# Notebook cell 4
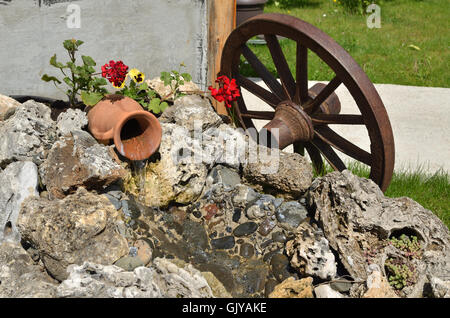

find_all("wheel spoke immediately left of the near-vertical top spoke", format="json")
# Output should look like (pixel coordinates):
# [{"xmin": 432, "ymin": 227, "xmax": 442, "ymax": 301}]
[{"xmin": 264, "ymin": 34, "xmax": 295, "ymax": 100}]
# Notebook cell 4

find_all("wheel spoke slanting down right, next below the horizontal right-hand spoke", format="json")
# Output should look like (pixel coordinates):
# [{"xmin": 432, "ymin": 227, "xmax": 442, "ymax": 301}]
[{"xmin": 315, "ymin": 126, "xmax": 372, "ymax": 166}]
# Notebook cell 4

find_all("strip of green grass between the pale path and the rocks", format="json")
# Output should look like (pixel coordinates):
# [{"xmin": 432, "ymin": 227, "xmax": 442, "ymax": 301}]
[{"xmin": 316, "ymin": 161, "xmax": 450, "ymax": 228}]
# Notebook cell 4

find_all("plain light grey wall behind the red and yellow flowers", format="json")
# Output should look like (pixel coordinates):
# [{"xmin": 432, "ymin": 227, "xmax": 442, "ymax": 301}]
[{"xmin": 0, "ymin": 0, "xmax": 208, "ymax": 97}]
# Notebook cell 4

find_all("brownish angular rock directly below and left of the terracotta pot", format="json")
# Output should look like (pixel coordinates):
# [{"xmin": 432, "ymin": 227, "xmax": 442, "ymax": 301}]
[{"xmin": 39, "ymin": 130, "xmax": 126, "ymax": 198}]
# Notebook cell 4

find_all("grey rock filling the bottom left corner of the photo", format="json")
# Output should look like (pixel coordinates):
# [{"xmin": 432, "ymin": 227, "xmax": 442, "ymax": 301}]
[{"xmin": 0, "ymin": 242, "xmax": 56, "ymax": 298}]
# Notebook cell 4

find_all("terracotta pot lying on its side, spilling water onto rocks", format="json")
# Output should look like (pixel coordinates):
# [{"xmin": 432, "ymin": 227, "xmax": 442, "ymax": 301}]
[{"xmin": 88, "ymin": 95, "xmax": 162, "ymax": 160}]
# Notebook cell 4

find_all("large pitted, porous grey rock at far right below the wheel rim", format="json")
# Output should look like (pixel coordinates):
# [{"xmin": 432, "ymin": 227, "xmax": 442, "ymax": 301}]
[{"xmin": 307, "ymin": 170, "xmax": 450, "ymax": 290}]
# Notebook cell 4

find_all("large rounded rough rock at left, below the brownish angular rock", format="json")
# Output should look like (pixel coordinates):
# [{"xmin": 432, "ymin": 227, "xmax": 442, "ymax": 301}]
[{"xmin": 17, "ymin": 188, "xmax": 128, "ymax": 281}]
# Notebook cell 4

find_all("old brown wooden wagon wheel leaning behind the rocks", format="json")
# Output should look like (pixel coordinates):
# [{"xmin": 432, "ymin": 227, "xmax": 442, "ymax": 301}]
[{"xmin": 220, "ymin": 14, "xmax": 394, "ymax": 191}]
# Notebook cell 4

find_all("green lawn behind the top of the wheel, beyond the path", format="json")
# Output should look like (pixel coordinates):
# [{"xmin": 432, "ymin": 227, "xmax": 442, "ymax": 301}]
[{"xmin": 242, "ymin": 0, "xmax": 450, "ymax": 87}]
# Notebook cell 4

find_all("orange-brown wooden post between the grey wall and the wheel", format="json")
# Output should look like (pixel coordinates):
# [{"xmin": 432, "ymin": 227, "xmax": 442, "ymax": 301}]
[{"xmin": 208, "ymin": 0, "xmax": 236, "ymax": 115}]
